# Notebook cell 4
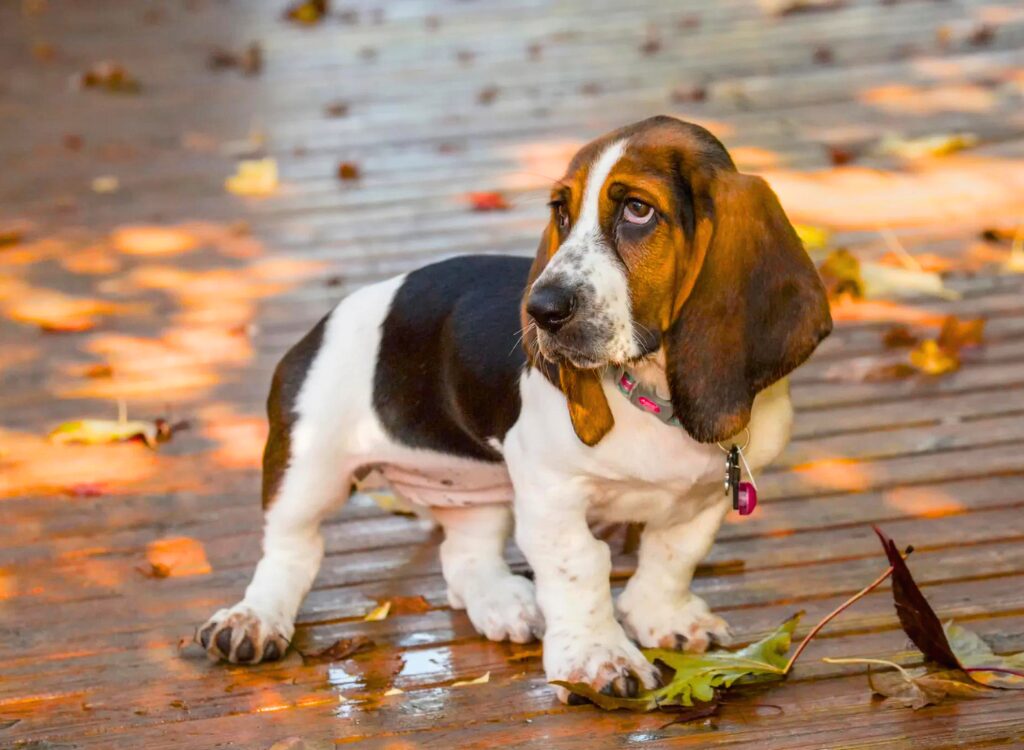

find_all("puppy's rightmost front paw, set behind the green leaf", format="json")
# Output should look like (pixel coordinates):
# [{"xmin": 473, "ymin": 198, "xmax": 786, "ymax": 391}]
[{"xmin": 615, "ymin": 588, "xmax": 732, "ymax": 654}]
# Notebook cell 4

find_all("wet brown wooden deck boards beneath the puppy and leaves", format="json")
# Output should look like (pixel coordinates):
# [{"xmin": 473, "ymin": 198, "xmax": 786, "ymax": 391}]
[{"xmin": 0, "ymin": 0, "xmax": 1024, "ymax": 750}]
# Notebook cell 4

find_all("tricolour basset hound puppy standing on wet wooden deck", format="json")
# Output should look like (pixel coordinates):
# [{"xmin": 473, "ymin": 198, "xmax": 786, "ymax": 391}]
[{"xmin": 196, "ymin": 117, "xmax": 831, "ymax": 701}]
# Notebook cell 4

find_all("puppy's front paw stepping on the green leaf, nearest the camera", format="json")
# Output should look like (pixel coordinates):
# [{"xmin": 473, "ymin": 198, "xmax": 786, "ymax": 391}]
[{"xmin": 544, "ymin": 625, "xmax": 660, "ymax": 703}]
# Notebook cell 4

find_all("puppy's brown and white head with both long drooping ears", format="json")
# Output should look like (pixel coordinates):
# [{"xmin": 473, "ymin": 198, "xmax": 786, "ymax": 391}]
[{"xmin": 522, "ymin": 117, "xmax": 831, "ymax": 446}]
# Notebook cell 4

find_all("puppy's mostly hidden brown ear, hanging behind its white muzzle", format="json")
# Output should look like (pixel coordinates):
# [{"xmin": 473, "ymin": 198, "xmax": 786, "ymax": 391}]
[{"xmin": 519, "ymin": 224, "xmax": 615, "ymax": 446}]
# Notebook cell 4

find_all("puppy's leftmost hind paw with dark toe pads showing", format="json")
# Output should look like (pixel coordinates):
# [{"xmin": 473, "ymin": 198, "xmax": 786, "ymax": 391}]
[{"xmin": 196, "ymin": 603, "xmax": 295, "ymax": 664}]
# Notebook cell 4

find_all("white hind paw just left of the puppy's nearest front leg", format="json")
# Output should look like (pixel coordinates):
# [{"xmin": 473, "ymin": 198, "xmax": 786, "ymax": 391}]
[{"xmin": 460, "ymin": 576, "xmax": 544, "ymax": 643}]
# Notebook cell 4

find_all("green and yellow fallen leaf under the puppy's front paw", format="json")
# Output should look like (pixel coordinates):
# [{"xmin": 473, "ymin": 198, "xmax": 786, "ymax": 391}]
[{"xmin": 552, "ymin": 614, "xmax": 801, "ymax": 711}]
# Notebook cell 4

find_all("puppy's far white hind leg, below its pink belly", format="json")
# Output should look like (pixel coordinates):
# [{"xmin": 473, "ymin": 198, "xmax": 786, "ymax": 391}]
[{"xmin": 431, "ymin": 505, "xmax": 544, "ymax": 643}]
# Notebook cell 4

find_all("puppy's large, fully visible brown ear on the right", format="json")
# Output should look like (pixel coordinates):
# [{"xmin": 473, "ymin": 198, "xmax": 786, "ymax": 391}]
[{"xmin": 665, "ymin": 170, "xmax": 831, "ymax": 443}]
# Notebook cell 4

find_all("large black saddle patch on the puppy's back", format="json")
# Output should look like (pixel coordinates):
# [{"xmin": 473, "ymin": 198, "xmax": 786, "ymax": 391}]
[{"xmin": 374, "ymin": 255, "xmax": 530, "ymax": 461}]
